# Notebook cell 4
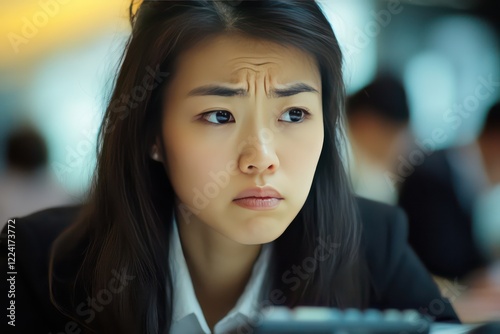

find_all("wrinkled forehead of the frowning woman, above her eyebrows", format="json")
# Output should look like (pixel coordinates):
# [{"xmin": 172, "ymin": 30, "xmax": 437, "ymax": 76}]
[{"xmin": 172, "ymin": 35, "xmax": 321, "ymax": 90}]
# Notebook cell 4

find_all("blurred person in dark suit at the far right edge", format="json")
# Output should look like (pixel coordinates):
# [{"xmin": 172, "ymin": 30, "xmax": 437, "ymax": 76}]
[{"xmin": 399, "ymin": 103, "xmax": 500, "ymax": 279}]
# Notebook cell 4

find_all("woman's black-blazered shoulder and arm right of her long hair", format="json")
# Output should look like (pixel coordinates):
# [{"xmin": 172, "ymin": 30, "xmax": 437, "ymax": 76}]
[{"xmin": 357, "ymin": 198, "xmax": 458, "ymax": 321}]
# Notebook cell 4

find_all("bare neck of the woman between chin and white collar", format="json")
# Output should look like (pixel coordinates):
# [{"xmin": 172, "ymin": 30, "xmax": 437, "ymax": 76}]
[{"xmin": 176, "ymin": 209, "xmax": 261, "ymax": 329}]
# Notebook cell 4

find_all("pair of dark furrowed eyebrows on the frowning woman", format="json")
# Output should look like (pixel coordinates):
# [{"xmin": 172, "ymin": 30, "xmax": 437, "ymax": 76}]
[{"xmin": 188, "ymin": 82, "xmax": 318, "ymax": 97}]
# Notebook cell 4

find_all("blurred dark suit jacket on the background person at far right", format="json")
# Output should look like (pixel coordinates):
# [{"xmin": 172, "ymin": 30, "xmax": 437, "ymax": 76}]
[{"xmin": 399, "ymin": 149, "xmax": 486, "ymax": 279}]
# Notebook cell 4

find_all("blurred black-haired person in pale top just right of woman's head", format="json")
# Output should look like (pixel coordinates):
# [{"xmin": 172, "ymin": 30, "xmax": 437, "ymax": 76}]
[{"xmin": 347, "ymin": 75, "xmax": 410, "ymax": 204}]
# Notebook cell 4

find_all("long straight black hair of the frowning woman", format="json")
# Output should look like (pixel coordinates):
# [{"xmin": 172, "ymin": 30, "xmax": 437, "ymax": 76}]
[{"xmin": 50, "ymin": 0, "xmax": 366, "ymax": 333}]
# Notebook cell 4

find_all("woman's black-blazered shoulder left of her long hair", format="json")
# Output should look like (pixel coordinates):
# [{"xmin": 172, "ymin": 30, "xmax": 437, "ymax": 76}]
[{"xmin": 0, "ymin": 206, "xmax": 80, "ymax": 332}]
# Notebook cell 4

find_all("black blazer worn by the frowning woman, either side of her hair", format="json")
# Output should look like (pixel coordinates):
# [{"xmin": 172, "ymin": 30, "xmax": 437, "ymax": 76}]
[{"xmin": 0, "ymin": 199, "xmax": 458, "ymax": 334}]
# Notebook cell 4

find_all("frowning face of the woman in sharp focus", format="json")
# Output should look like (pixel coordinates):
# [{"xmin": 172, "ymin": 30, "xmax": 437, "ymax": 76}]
[{"xmin": 158, "ymin": 35, "xmax": 323, "ymax": 245}]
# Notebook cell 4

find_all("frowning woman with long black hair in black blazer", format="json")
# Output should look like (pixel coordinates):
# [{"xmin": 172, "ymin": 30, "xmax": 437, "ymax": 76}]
[{"xmin": 1, "ymin": 0, "xmax": 456, "ymax": 333}]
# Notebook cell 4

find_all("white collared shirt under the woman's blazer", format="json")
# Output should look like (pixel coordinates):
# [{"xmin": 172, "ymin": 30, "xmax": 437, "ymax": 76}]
[{"xmin": 169, "ymin": 218, "xmax": 272, "ymax": 334}]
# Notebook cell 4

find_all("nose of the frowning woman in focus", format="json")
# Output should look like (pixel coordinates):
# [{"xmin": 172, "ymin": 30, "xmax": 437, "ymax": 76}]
[{"xmin": 238, "ymin": 133, "xmax": 279, "ymax": 175}]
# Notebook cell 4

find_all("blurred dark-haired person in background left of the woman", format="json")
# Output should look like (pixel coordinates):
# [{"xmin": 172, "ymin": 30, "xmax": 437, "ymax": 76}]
[{"xmin": 0, "ymin": 126, "xmax": 74, "ymax": 228}]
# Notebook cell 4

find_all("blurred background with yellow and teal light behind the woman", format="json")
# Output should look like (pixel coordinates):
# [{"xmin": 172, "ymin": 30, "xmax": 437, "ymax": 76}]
[{"xmin": 0, "ymin": 0, "xmax": 500, "ymax": 321}]
